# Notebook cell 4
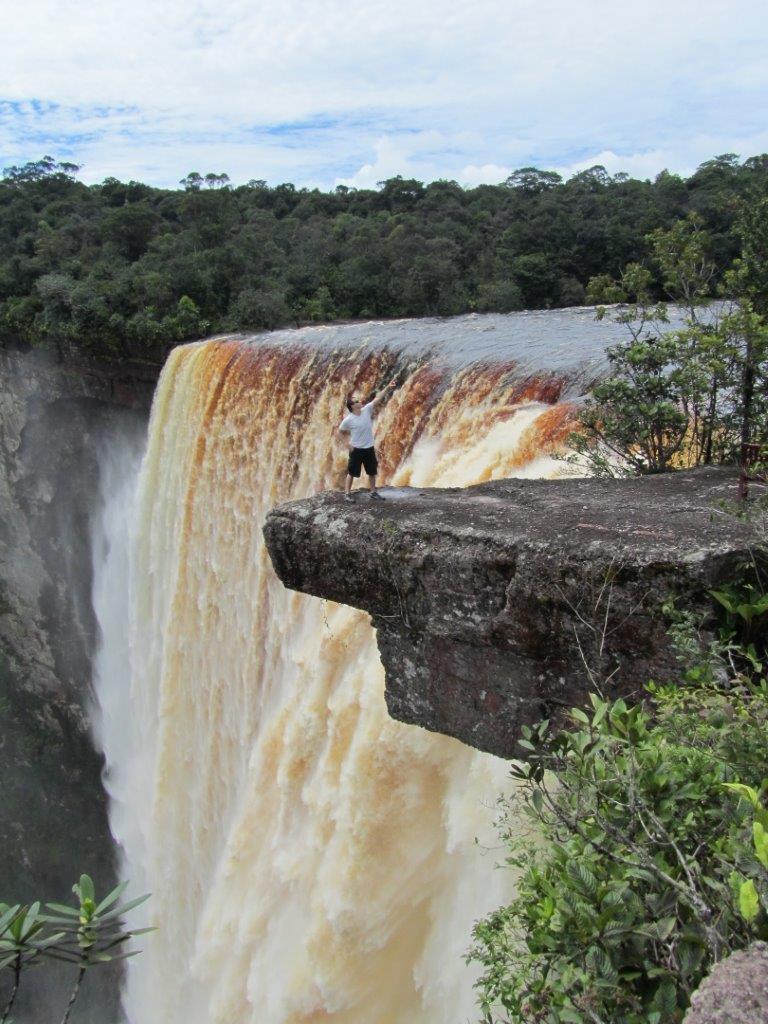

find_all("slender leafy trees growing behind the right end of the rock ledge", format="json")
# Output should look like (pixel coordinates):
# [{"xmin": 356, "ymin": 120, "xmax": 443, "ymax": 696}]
[{"xmin": 569, "ymin": 207, "xmax": 768, "ymax": 476}]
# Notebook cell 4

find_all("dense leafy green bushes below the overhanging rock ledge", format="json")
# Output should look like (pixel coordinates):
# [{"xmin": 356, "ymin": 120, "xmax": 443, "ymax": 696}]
[{"xmin": 470, "ymin": 588, "xmax": 768, "ymax": 1024}]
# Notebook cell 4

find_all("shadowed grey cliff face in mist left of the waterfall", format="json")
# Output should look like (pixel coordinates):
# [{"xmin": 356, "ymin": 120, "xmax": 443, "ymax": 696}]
[{"xmin": 0, "ymin": 350, "xmax": 156, "ymax": 1020}]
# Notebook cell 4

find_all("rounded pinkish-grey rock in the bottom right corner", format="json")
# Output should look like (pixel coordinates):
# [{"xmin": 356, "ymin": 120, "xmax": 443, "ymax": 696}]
[{"xmin": 684, "ymin": 942, "xmax": 768, "ymax": 1024}]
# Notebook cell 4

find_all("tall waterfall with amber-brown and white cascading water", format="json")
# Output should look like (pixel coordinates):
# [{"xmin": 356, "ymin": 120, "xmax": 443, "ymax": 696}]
[{"xmin": 94, "ymin": 340, "xmax": 570, "ymax": 1024}]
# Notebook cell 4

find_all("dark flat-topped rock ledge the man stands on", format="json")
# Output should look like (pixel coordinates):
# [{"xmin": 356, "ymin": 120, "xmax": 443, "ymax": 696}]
[{"xmin": 264, "ymin": 470, "xmax": 758, "ymax": 756}]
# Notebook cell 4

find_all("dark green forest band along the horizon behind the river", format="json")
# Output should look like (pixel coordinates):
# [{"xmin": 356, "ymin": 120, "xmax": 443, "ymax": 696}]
[{"xmin": 0, "ymin": 154, "xmax": 768, "ymax": 361}]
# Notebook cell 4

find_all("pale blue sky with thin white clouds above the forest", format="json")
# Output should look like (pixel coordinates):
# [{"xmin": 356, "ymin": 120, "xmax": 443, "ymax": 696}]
[{"xmin": 0, "ymin": 0, "xmax": 768, "ymax": 187}]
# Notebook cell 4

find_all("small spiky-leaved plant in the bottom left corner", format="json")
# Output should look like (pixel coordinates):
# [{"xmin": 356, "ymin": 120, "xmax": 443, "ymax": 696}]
[{"xmin": 0, "ymin": 874, "xmax": 152, "ymax": 1024}]
